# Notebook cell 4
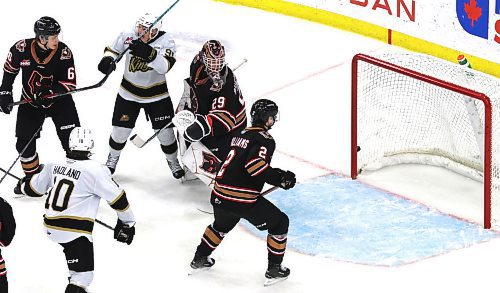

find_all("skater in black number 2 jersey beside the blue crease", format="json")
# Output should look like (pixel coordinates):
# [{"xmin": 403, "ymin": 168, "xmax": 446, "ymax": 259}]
[{"xmin": 191, "ymin": 99, "xmax": 295, "ymax": 285}]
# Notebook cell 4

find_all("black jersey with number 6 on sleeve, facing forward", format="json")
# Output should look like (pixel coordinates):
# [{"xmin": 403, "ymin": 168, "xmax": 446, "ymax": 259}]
[{"xmin": 2, "ymin": 38, "xmax": 76, "ymax": 100}]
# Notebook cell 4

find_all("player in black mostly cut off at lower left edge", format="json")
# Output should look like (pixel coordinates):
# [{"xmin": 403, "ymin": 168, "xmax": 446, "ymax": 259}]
[{"xmin": 0, "ymin": 197, "xmax": 16, "ymax": 292}]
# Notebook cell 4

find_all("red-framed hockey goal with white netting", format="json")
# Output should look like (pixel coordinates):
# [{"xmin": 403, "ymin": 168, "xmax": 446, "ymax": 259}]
[{"xmin": 351, "ymin": 53, "xmax": 500, "ymax": 228}]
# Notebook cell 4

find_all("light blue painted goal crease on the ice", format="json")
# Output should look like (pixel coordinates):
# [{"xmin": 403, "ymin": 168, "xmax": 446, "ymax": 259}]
[{"xmin": 242, "ymin": 175, "xmax": 500, "ymax": 266}]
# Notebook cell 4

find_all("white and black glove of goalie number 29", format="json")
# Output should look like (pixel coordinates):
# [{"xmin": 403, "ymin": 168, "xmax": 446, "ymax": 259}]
[{"xmin": 172, "ymin": 110, "xmax": 212, "ymax": 142}]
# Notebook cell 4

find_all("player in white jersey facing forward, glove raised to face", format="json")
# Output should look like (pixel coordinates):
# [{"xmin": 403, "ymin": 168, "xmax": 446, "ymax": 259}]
[{"xmin": 98, "ymin": 13, "xmax": 184, "ymax": 179}]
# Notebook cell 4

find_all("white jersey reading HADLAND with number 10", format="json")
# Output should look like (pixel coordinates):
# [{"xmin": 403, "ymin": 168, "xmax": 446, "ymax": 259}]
[{"xmin": 22, "ymin": 159, "xmax": 135, "ymax": 243}]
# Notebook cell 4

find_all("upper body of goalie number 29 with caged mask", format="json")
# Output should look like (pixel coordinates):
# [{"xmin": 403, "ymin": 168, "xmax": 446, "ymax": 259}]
[{"xmin": 177, "ymin": 40, "xmax": 247, "ymax": 160}]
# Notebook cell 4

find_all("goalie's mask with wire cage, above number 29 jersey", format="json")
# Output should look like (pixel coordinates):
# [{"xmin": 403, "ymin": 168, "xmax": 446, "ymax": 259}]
[{"xmin": 200, "ymin": 40, "xmax": 227, "ymax": 91}]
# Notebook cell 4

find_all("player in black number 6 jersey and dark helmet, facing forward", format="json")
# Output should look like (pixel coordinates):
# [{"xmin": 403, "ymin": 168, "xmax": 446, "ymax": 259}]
[{"xmin": 0, "ymin": 16, "xmax": 80, "ymax": 194}]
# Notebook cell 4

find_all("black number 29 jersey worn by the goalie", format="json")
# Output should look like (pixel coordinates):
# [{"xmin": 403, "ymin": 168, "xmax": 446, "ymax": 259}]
[{"xmin": 188, "ymin": 54, "xmax": 247, "ymax": 159}]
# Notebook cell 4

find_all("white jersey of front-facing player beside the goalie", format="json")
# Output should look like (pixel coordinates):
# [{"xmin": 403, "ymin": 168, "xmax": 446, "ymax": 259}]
[{"xmin": 104, "ymin": 31, "xmax": 176, "ymax": 103}]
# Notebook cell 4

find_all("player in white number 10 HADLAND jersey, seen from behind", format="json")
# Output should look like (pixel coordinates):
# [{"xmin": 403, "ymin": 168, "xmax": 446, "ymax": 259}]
[{"xmin": 21, "ymin": 127, "xmax": 135, "ymax": 293}]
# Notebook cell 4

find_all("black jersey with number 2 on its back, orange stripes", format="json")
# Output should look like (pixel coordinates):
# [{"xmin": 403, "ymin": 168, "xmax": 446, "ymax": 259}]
[{"xmin": 212, "ymin": 127, "xmax": 283, "ymax": 204}]
